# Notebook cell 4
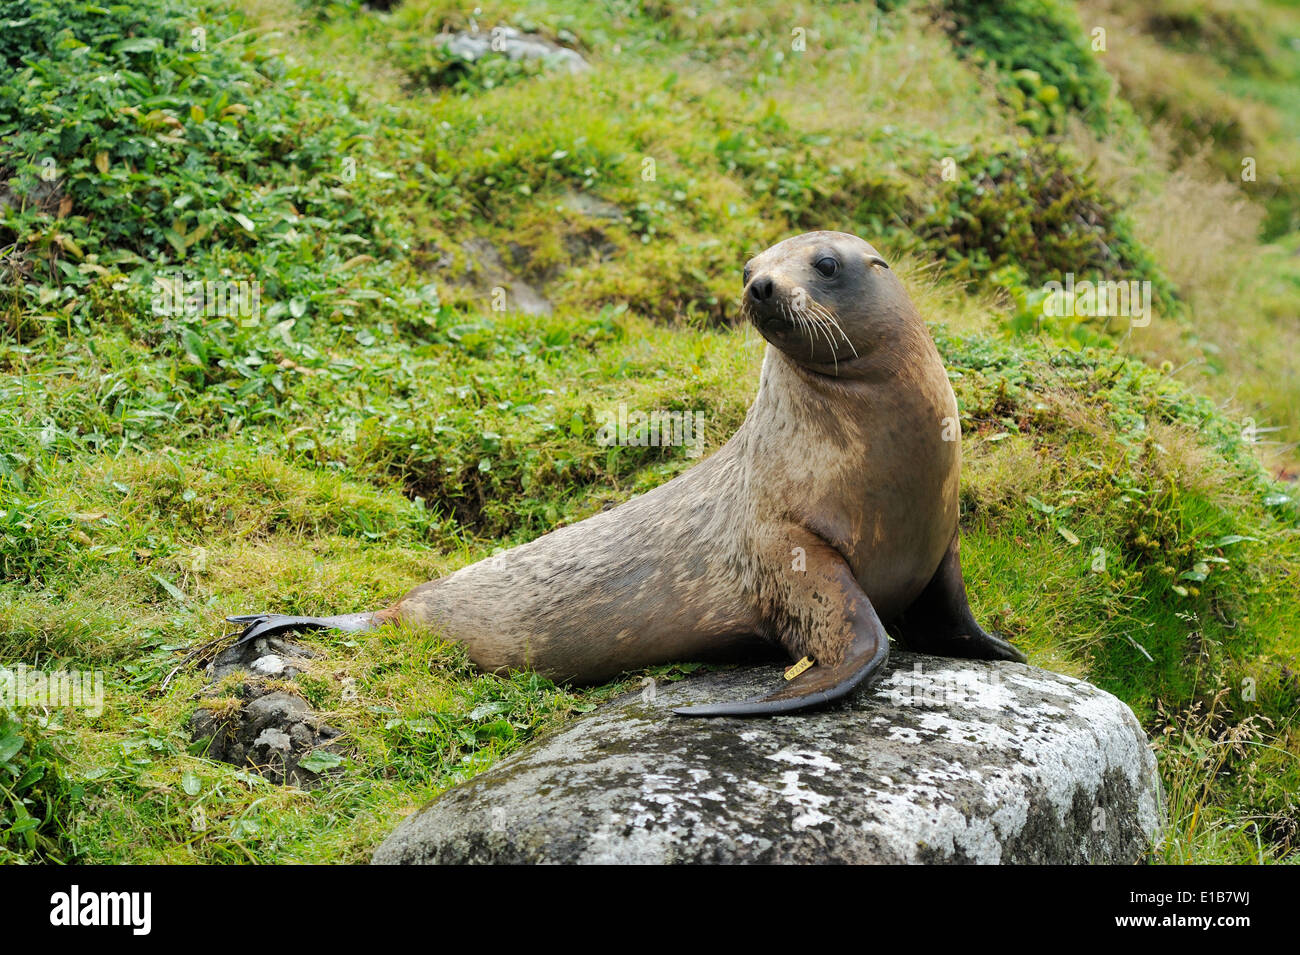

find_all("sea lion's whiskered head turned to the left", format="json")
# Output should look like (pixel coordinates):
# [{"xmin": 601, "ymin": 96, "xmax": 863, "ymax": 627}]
[{"xmin": 741, "ymin": 233, "xmax": 919, "ymax": 377}]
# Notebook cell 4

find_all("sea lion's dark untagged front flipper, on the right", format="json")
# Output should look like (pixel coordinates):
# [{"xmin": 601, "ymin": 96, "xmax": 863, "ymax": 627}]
[{"xmin": 897, "ymin": 531, "xmax": 1027, "ymax": 663}]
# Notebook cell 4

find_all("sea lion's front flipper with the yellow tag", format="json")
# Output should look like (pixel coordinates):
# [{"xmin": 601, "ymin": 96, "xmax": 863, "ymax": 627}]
[{"xmin": 672, "ymin": 542, "xmax": 889, "ymax": 716}]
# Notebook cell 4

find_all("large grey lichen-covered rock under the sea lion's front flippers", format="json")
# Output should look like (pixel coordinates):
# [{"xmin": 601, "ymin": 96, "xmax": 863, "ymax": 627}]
[{"xmin": 374, "ymin": 652, "xmax": 1162, "ymax": 863}]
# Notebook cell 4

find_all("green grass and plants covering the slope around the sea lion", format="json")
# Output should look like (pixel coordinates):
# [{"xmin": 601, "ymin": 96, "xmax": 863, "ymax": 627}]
[{"xmin": 0, "ymin": 0, "xmax": 1300, "ymax": 863}]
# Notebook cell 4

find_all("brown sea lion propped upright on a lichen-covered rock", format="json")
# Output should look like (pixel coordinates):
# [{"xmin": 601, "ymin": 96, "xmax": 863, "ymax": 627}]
[{"xmin": 231, "ymin": 231, "xmax": 1024, "ymax": 716}]
